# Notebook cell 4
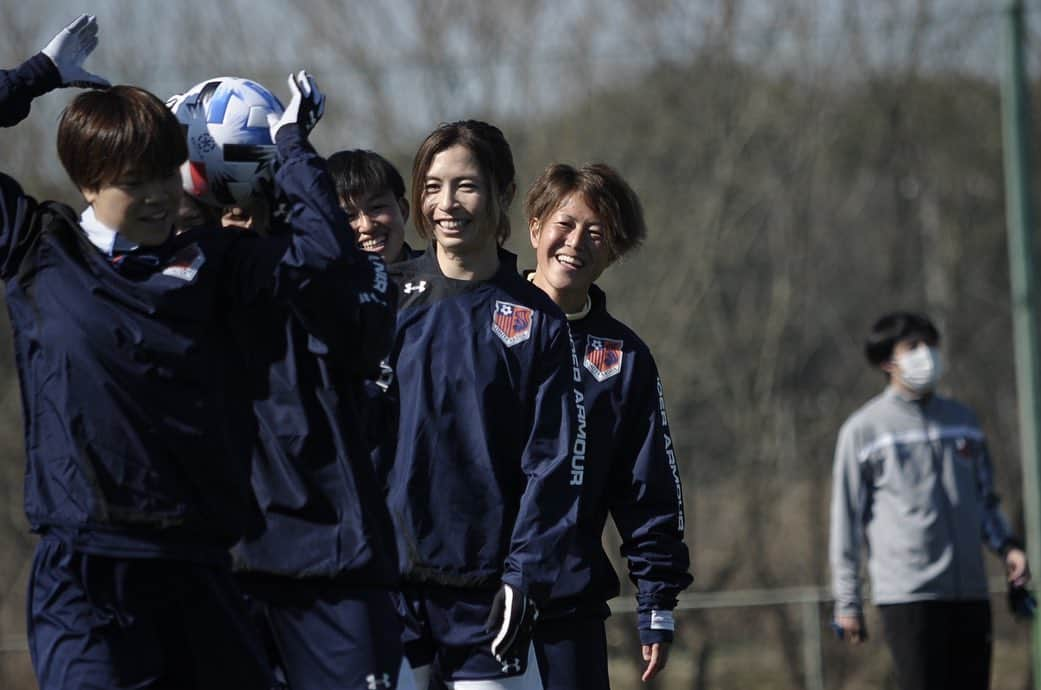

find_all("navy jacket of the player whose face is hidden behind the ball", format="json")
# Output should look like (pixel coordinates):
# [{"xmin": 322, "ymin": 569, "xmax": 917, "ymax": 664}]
[{"xmin": 232, "ymin": 250, "xmax": 398, "ymax": 586}]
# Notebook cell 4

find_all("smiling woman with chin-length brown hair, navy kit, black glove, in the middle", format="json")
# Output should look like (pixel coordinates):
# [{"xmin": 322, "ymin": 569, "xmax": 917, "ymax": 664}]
[{"xmin": 380, "ymin": 121, "xmax": 585, "ymax": 690}]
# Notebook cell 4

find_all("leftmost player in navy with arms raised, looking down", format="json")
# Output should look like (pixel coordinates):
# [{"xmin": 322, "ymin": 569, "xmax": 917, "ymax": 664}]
[{"xmin": 0, "ymin": 15, "xmax": 355, "ymax": 690}]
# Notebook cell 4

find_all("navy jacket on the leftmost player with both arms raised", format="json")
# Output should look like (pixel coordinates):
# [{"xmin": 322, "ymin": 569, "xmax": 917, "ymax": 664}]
[{"xmin": 0, "ymin": 54, "xmax": 366, "ymax": 561}]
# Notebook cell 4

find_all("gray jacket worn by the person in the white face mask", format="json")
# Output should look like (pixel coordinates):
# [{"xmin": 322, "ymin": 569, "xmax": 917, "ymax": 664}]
[{"xmin": 829, "ymin": 387, "xmax": 1015, "ymax": 616}]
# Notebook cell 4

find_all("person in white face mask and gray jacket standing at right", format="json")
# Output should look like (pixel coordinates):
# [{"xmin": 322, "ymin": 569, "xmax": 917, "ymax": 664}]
[{"xmin": 830, "ymin": 311, "xmax": 1031, "ymax": 690}]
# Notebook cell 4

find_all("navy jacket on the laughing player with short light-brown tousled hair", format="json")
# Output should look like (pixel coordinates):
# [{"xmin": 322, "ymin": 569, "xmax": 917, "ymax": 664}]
[{"xmin": 541, "ymin": 285, "xmax": 691, "ymax": 644}]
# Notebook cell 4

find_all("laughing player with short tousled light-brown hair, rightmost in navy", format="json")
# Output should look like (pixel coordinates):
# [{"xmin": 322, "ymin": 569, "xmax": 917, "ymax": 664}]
[{"xmin": 525, "ymin": 163, "xmax": 691, "ymax": 690}]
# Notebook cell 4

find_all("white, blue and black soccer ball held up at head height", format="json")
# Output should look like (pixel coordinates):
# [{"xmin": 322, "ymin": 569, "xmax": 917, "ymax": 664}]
[{"xmin": 167, "ymin": 77, "xmax": 284, "ymax": 207}]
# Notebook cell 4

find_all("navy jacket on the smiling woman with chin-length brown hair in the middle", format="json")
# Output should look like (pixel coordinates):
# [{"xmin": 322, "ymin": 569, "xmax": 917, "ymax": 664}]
[{"xmin": 384, "ymin": 248, "xmax": 585, "ymax": 603}]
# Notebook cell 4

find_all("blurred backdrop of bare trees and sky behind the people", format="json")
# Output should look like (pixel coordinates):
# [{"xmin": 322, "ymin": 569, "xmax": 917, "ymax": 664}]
[{"xmin": 0, "ymin": 0, "xmax": 1038, "ymax": 689}]
